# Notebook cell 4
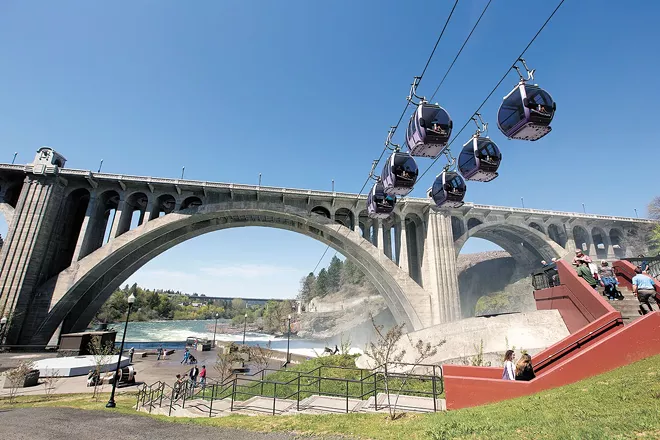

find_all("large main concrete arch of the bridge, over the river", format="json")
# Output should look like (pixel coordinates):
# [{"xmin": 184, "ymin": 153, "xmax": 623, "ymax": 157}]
[{"xmin": 32, "ymin": 201, "xmax": 432, "ymax": 344}]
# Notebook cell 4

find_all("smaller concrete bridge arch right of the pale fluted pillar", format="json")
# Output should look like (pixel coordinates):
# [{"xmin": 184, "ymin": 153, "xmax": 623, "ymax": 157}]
[{"xmin": 454, "ymin": 222, "xmax": 566, "ymax": 267}]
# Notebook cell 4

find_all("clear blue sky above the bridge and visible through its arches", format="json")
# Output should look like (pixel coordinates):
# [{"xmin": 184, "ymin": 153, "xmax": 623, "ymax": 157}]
[{"xmin": 0, "ymin": 0, "xmax": 660, "ymax": 297}]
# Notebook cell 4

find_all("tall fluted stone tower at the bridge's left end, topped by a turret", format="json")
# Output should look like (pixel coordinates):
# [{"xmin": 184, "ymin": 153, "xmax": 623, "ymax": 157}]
[{"xmin": 0, "ymin": 147, "xmax": 66, "ymax": 344}]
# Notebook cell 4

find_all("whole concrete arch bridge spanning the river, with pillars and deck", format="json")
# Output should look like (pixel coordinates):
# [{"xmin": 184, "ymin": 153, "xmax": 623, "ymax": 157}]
[{"xmin": 0, "ymin": 147, "xmax": 655, "ymax": 344}]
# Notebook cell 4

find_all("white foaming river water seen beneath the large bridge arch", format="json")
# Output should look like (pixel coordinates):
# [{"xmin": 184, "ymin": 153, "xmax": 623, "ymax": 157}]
[{"xmin": 108, "ymin": 319, "xmax": 338, "ymax": 357}]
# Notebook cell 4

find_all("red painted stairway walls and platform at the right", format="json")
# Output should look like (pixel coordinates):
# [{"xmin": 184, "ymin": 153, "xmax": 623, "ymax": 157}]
[{"xmin": 443, "ymin": 261, "xmax": 660, "ymax": 410}]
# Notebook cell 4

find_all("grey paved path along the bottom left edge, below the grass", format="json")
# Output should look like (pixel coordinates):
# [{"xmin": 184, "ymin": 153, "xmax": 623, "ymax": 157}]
[{"xmin": 0, "ymin": 408, "xmax": 346, "ymax": 440}]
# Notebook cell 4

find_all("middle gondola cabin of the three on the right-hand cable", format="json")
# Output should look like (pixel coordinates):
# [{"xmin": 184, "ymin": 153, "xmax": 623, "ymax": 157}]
[{"xmin": 458, "ymin": 135, "xmax": 502, "ymax": 182}]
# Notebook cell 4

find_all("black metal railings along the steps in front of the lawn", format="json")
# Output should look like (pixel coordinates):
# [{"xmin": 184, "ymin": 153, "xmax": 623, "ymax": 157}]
[{"xmin": 136, "ymin": 362, "xmax": 444, "ymax": 417}]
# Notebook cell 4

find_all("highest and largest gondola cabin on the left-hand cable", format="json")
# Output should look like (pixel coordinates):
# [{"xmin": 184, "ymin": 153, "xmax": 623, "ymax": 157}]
[{"xmin": 406, "ymin": 102, "xmax": 453, "ymax": 158}]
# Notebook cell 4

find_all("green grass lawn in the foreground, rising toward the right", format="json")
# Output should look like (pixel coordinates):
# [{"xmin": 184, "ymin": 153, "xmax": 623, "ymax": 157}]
[{"xmin": 0, "ymin": 356, "xmax": 660, "ymax": 440}]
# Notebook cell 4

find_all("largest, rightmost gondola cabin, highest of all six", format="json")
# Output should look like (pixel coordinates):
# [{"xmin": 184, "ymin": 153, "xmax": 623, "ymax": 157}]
[{"xmin": 497, "ymin": 82, "xmax": 557, "ymax": 141}]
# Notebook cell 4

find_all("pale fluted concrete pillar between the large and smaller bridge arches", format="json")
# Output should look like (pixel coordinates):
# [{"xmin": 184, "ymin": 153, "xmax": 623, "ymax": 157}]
[{"xmin": 422, "ymin": 211, "xmax": 461, "ymax": 324}]
